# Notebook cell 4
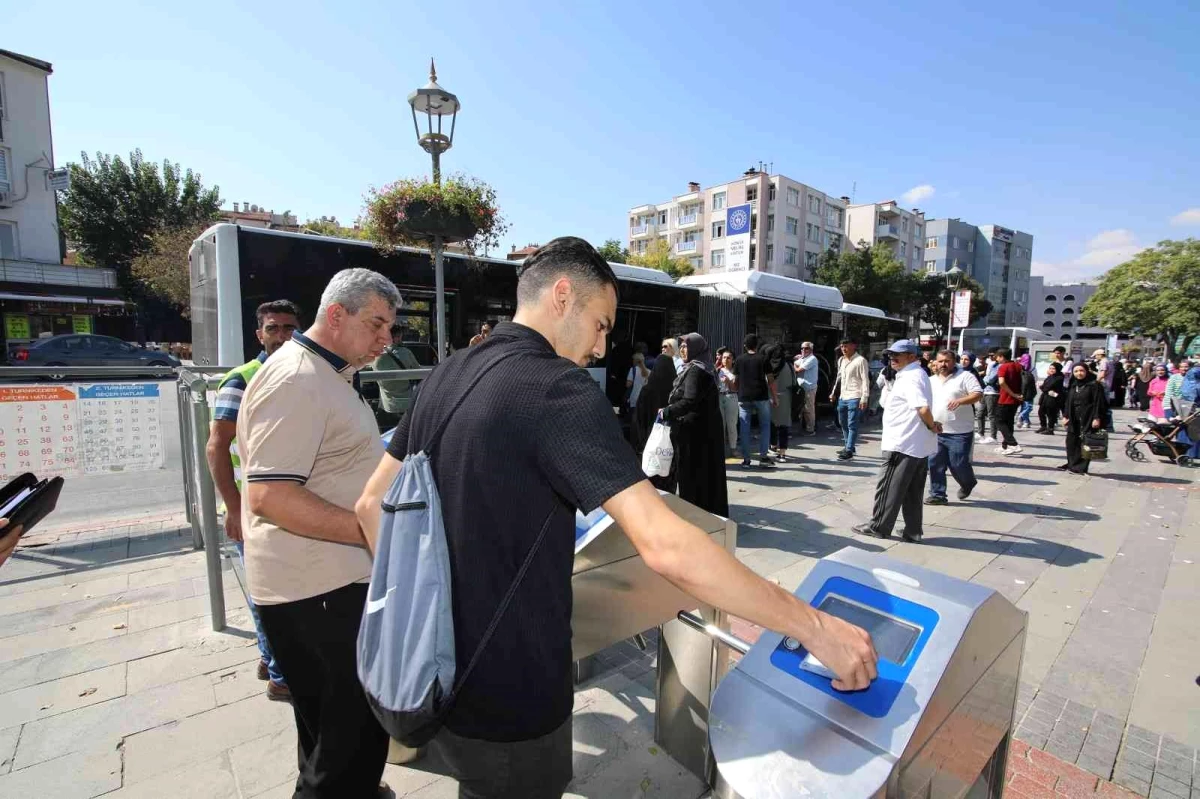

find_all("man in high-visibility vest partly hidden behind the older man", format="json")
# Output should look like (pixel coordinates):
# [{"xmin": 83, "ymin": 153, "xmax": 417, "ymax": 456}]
[{"xmin": 206, "ymin": 300, "xmax": 300, "ymax": 702}]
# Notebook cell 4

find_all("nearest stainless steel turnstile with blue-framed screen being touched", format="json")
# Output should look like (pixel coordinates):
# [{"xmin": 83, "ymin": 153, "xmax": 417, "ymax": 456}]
[{"xmin": 705, "ymin": 547, "xmax": 1026, "ymax": 799}]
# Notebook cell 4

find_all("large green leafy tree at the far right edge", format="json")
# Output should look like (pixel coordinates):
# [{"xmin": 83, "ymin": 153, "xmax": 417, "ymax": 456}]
[{"xmin": 1080, "ymin": 238, "xmax": 1200, "ymax": 359}]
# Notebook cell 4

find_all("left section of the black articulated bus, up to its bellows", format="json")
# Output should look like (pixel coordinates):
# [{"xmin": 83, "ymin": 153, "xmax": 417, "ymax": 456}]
[{"xmin": 188, "ymin": 223, "xmax": 700, "ymax": 392}]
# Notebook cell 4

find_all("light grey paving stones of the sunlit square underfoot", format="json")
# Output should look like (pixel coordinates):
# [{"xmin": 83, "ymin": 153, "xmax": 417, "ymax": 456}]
[{"xmin": 0, "ymin": 410, "xmax": 1200, "ymax": 799}]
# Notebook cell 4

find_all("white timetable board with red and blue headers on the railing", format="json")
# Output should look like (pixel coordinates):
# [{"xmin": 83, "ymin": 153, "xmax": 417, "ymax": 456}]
[{"xmin": 0, "ymin": 383, "xmax": 166, "ymax": 480}]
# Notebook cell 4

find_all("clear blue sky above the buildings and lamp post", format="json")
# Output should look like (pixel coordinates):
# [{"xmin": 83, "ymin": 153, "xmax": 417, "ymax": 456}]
[{"xmin": 9, "ymin": 0, "xmax": 1200, "ymax": 280}]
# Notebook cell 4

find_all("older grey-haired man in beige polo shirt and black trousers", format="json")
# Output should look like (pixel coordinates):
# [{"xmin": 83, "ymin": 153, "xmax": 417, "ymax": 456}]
[{"xmin": 238, "ymin": 269, "xmax": 400, "ymax": 799}]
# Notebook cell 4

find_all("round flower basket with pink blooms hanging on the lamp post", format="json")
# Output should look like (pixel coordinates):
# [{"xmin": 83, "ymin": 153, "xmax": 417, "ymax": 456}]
[{"xmin": 365, "ymin": 175, "xmax": 508, "ymax": 253}]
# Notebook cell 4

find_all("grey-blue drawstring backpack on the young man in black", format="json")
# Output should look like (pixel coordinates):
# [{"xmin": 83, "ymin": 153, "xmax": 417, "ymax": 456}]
[{"xmin": 358, "ymin": 353, "xmax": 551, "ymax": 749}]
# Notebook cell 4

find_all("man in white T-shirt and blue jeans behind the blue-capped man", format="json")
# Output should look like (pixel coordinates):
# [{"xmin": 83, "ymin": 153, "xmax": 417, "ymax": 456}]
[{"xmin": 925, "ymin": 349, "xmax": 983, "ymax": 505}]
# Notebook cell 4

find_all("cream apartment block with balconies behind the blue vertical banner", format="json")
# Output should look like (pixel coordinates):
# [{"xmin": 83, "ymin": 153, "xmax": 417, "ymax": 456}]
[{"xmin": 629, "ymin": 169, "xmax": 846, "ymax": 280}]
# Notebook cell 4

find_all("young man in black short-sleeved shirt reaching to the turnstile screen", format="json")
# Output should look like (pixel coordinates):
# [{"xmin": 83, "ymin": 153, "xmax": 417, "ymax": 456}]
[{"xmin": 356, "ymin": 238, "xmax": 876, "ymax": 799}]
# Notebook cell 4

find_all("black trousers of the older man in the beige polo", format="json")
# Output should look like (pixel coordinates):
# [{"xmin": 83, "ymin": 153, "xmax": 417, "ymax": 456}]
[{"xmin": 258, "ymin": 583, "xmax": 388, "ymax": 799}]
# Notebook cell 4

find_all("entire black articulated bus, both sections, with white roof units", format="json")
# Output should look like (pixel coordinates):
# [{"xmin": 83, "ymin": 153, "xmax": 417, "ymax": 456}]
[{"xmin": 188, "ymin": 223, "xmax": 902, "ymax": 405}]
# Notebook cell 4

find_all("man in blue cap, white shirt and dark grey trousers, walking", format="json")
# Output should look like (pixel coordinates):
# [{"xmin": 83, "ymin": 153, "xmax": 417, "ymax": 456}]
[{"xmin": 853, "ymin": 338, "xmax": 942, "ymax": 543}]
